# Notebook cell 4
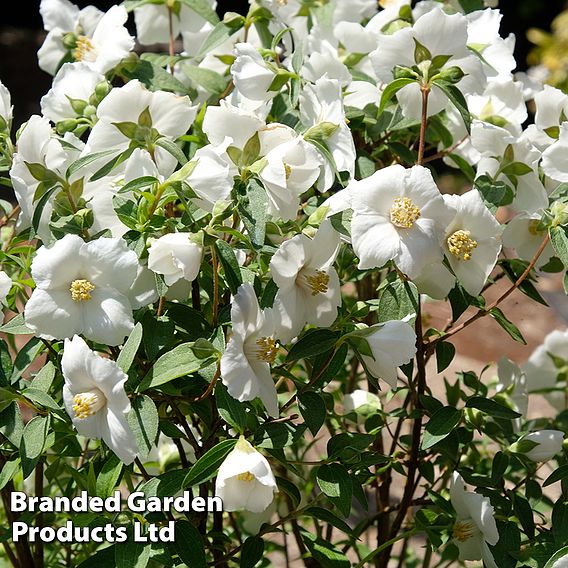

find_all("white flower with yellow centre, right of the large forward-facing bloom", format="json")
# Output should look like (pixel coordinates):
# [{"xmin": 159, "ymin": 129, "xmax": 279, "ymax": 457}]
[{"xmin": 444, "ymin": 191, "xmax": 501, "ymax": 296}]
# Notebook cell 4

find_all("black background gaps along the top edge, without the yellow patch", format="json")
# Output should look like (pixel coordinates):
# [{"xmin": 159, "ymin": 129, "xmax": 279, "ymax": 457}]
[{"xmin": 0, "ymin": 0, "xmax": 567, "ymax": 127}]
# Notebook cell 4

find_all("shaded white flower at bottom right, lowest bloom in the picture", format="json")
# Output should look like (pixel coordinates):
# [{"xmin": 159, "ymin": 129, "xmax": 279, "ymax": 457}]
[{"xmin": 450, "ymin": 472, "xmax": 499, "ymax": 568}]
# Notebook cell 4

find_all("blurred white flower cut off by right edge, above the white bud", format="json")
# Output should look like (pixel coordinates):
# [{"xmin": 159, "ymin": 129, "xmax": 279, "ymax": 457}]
[{"xmin": 522, "ymin": 329, "xmax": 568, "ymax": 412}]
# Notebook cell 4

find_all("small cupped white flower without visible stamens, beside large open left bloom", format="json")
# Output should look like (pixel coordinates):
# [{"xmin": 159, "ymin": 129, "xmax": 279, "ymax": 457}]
[{"xmin": 148, "ymin": 233, "xmax": 203, "ymax": 286}]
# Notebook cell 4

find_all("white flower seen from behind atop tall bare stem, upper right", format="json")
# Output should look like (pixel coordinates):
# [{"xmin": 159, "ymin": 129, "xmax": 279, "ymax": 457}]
[{"xmin": 369, "ymin": 8, "xmax": 487, "ymax": 119}]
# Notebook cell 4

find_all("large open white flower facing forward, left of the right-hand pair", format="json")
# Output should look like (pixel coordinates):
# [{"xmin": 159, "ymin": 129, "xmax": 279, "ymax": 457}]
[{"xmin": 347, "ymin": 164, "xmax": 450, "ymax": 278}]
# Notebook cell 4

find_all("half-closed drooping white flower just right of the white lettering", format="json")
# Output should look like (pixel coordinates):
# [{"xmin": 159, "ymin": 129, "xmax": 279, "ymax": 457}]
[{"xmin": 215, "ymin": 436, "xmax": 278, "ymax": 513}]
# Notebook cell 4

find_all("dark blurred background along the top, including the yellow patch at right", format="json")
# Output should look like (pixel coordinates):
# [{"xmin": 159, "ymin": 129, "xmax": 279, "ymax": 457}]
[{"xmin": 0, "ymin": 0, "xmax": 568, "ymax": 128}]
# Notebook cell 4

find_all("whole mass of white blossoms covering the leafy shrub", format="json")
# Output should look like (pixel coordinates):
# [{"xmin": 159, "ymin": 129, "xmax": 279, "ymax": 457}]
[{"xmin": 0, "ymin": 0, "xmax": 568, "ymax": 568}]
